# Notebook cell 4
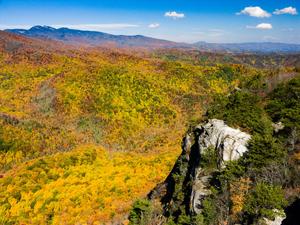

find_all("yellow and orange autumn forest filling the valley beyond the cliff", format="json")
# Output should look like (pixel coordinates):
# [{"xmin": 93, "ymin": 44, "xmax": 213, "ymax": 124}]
[{"xmin": 0, "ymin": 32, "xmax": 297, "ymax": 225}]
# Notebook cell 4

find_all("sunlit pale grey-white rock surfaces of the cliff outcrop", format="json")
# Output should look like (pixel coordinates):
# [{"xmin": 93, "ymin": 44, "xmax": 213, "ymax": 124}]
[{"xmin": 190, "ymin": 119, "xmax": 251, "ymax": 214}]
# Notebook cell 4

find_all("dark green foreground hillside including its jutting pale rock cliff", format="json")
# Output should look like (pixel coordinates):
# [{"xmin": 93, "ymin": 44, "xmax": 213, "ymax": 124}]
[{"xmin": 129, "ymin": 75, "xmax": 300, "ymax": 225}]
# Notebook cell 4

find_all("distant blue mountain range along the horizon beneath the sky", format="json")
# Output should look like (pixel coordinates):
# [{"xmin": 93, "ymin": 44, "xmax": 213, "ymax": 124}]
[{"xmin": 5, "ymin": 26, "xmax": 300, "ymax": 53}]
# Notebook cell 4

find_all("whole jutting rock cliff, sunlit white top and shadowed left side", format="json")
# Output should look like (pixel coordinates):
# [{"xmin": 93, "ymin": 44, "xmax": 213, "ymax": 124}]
[{"xmin": 149, "ymin": 119, "xmax": 251, "ymax": 218}]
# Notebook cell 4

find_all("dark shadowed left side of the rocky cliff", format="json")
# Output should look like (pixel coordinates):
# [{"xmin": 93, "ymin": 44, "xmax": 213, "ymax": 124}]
[{"xmin": 148, "ymin": 129, "xmax": 203, "ymax": 218}]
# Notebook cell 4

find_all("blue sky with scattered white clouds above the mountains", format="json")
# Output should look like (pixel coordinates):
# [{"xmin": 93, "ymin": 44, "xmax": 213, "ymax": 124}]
[{"xmin": 0, "ymin": 0, "xmax": 300, "ymax": 44}]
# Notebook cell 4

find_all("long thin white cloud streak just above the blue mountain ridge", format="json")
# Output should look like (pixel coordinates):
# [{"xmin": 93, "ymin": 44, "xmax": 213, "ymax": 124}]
[{"xmin": 51, "ymin": 23, "xmax": 139, "ymax": 31}]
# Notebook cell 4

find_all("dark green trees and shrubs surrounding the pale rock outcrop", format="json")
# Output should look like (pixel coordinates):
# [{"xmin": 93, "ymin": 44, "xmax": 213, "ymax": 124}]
[{"xmin": 130, "ymin": 71, "xmax": 300, "ymax": 225}]
